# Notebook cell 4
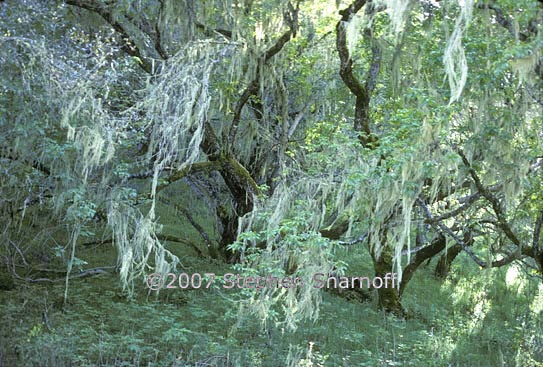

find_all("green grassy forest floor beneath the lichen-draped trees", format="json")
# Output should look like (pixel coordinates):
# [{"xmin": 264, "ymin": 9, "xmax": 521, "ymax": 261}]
[{"xmin": 0, "ymin": 245, "xmax": 543, "ymax": 367}]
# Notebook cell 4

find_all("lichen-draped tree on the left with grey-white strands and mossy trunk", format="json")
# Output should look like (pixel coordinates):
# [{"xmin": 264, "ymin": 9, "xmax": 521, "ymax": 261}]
[{"xmin": 4, "ymin": 1, "xmax": 306, "ymax": 294}]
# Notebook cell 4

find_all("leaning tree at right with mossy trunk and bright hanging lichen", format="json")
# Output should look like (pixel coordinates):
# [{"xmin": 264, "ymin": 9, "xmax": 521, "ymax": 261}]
[{"xmin": 328, "ymin": 1, "xmax": 542, "ymax": 314}]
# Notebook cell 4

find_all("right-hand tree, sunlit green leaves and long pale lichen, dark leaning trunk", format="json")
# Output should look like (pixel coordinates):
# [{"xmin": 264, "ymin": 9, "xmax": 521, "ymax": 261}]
[{"xmin": 235, "ymin": 1, "xmax": 542, "ymax": 322}]
